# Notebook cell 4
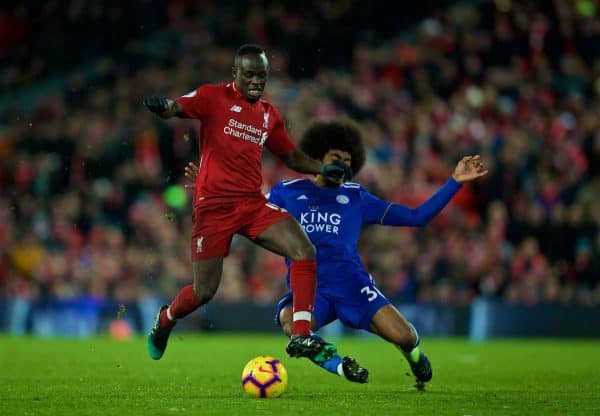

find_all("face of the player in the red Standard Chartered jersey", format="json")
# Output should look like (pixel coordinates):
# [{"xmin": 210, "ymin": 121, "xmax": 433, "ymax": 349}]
[{"xmin": 233, "ymin": 53, "xmax": 269, "ymax": 102}]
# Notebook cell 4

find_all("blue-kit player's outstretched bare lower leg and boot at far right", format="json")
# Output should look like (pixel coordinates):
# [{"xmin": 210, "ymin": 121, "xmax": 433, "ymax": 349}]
[{"xmin": 371, "ymin": 305, "xmax": 432, "ymax": 389}]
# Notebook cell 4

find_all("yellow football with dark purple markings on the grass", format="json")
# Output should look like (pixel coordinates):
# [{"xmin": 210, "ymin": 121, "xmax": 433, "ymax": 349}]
[{"xmin": 242, "ymin": 356, "xmax": 287, "ymax": 398}]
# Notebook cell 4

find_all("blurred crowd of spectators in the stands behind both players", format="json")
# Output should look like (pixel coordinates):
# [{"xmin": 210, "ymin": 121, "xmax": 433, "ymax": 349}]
[{"xmin": 0, "ymin": 0, "xmax": 600, "ymax": 305}]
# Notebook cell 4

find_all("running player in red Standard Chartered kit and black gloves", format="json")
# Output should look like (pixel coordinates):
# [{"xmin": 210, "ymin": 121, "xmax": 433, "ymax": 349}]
[{"xmin": 144, "ymin": 45, "xmax": 336, "ymax": 362}]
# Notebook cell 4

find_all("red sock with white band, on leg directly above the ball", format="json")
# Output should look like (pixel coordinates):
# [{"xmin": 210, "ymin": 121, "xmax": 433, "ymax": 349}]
[{"xmin": 290, "ymin": 260, "xmax": 317, "ymax": 335}]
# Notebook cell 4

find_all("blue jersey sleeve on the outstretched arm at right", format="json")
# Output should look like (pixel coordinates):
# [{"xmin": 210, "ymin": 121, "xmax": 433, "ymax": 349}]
[{"xmin": 361, "ymin": 178, "xmax": 462, "ymax": 227}]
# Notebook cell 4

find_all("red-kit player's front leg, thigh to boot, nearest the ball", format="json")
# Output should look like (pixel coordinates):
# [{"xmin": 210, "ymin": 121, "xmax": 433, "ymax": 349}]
[{"xmin": 255, "ymin": 217, "xmax": 336, "ymax": 362}]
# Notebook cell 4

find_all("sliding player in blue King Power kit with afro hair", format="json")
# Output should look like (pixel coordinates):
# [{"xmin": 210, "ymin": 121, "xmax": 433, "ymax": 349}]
[{"xmin": 186, "ymin": 120, "xmax": 487, "ymax": 386}]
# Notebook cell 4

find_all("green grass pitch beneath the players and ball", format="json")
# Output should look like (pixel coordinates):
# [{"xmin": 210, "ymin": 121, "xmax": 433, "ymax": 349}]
[{"xmin": 0, "ymin": 332, "xmax": 600, "ymax": 416}]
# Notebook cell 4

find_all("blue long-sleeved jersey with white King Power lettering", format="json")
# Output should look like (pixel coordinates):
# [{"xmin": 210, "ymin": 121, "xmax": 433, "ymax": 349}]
[{"xmin": 268, "ymin": 179, "xmax": 460, "ymax": 290}]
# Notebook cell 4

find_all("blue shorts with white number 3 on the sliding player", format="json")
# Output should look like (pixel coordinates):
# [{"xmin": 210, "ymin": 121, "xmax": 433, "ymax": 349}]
[{"xmin": 275, "ymin": 277, "xmax": 390, "ymax": 331}]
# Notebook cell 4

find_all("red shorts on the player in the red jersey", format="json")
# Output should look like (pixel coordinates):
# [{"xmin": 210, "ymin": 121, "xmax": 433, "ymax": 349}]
[{"xmin": 191, "ymin": 194, "xmax": 290, "ymax": 261}]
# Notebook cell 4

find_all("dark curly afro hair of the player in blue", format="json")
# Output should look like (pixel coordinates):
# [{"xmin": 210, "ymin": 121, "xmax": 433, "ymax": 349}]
[{"xmin": 300, "ymin": 119, "xmax": 366, "ymax": 179}]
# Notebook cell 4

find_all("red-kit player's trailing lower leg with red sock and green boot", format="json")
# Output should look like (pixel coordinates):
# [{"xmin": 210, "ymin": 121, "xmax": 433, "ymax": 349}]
[{"xmin": 147, "ymin": 257, "xmax": 223, "ymax": 360}]
